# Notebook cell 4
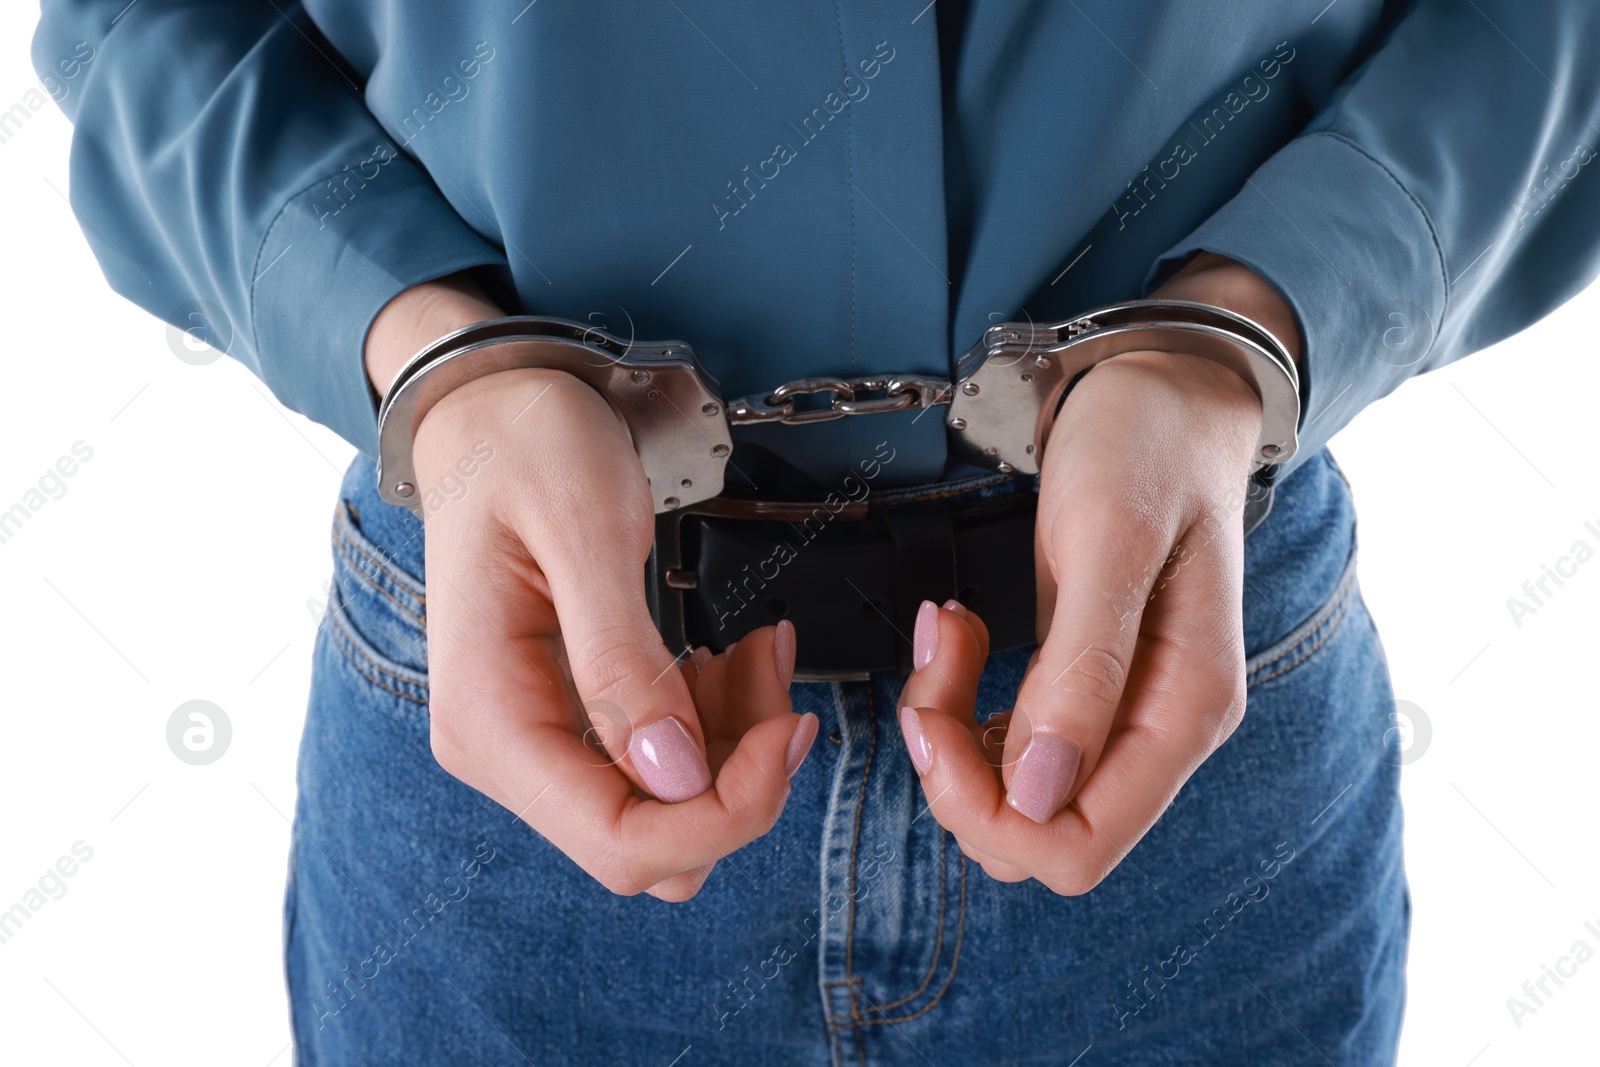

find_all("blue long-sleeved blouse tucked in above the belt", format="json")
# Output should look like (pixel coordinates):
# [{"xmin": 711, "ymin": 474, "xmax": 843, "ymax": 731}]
[{"xmin": 32, "ymin": 0, "xmax": 1600, "ymax": 483}]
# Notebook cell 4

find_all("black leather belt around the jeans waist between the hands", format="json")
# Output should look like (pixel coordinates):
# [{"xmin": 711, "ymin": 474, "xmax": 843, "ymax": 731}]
[{"xmin": 646, "ymin": 485, "xmax": 1038, "ymax": 681}]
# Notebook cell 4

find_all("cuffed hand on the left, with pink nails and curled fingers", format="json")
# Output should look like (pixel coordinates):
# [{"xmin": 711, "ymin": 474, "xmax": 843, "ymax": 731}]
[{"xmin": 370, "ymin": 278, "xmax": 818, "ymax": 901}]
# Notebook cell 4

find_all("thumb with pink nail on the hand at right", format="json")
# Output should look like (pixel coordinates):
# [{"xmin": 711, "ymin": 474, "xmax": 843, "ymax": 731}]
[{"xmin": 1002, "ymin": 483, "xmax": 1176, "ymax": 822}]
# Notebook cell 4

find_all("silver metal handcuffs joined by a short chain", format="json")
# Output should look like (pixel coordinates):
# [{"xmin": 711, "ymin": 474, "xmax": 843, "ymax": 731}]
[{"xmin": 378, "ymin": 301, "xmax": 1301, "ymax": 525}]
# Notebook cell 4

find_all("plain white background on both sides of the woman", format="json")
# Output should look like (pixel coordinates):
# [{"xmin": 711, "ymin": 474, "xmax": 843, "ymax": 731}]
[{"xmin": 0, "ymin": 5, "xmax": 1600, "ymax": 1067}]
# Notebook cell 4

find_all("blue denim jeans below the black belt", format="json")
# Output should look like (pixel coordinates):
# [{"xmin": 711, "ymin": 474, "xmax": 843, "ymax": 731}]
[{"xmin": 285, "ymin": 451, "xmax": 1410, "ymax": 1067}]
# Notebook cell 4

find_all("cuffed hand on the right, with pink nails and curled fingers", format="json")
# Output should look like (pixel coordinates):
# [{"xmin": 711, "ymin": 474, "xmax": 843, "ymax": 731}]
[{"xmin": 901, "ymin": 352, "xmax": 1261, "ymax": 894}]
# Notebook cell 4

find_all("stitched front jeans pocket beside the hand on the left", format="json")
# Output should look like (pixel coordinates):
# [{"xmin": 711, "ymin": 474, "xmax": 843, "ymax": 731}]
[{"xmin": 328, "ymin": 498, "xmax": 427, "ymax": 702}]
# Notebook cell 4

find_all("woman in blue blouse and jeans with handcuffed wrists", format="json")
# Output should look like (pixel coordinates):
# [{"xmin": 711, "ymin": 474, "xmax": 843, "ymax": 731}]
[{"xmin": 34, "ymin": 0, "xmax": 1600, "ymax": 1064}]
